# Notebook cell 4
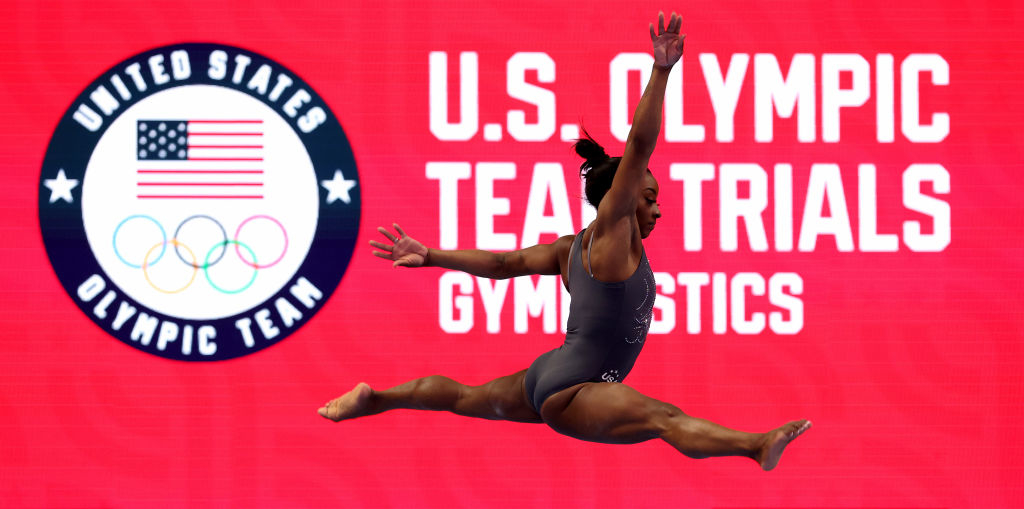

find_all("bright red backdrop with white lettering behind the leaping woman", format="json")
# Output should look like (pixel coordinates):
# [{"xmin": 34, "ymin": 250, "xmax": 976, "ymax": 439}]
[{"xmin": 0, "ymin": 1, "xmax": 1024, "ymax": 508}]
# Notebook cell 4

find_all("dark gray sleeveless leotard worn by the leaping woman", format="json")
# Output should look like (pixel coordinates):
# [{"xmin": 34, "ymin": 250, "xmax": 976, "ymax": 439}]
[{"xmin": 525, "ymin": 229, "xmax": 654, "ymax": 412}]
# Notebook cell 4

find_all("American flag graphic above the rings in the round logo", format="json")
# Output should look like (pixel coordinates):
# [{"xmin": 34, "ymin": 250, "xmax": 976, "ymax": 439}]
[{"xmin": 135, "ymin": 119, "xmax": 263, "ymax": 200}]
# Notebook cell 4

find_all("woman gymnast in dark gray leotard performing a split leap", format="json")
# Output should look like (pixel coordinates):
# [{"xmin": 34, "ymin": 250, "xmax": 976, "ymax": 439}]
[{"xmin": 318, "ymin": 13, "xmax": 811, "ymax": 470}]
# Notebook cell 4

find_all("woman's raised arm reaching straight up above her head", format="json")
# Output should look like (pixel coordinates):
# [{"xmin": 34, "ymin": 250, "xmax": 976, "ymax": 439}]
[{"xmin": 598, "ymin": 12, "xmax": 686, "ymax": 221}]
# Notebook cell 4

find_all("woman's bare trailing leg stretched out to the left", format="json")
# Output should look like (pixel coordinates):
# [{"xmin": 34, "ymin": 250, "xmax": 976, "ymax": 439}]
[{"xmin": 317, "ymin": 370, "xmax": 543, "ymax": 423}]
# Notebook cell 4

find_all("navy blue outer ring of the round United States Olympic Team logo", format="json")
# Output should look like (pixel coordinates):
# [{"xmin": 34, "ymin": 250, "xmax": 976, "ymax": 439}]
[{"xmin": 39, "ymin": 43, "xmax": 361, "ymax": 362}]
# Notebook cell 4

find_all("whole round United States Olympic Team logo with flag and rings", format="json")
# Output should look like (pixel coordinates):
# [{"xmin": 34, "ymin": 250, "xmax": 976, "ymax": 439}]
[{"xmin": 39, "ymin": 43, "xmax": 360, "ymax": 360}]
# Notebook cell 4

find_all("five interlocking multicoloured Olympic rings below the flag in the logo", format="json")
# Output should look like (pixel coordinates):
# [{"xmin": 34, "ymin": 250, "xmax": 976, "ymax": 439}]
[{"xmin": 112, "ymin": 214, "xmax": 289, "ymax": 295}]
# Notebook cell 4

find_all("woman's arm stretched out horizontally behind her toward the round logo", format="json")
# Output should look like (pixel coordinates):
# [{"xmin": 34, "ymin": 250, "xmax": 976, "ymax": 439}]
[{"xmin": 370, "ymin": 223, "xmax": 572, "ymax": 280}]
